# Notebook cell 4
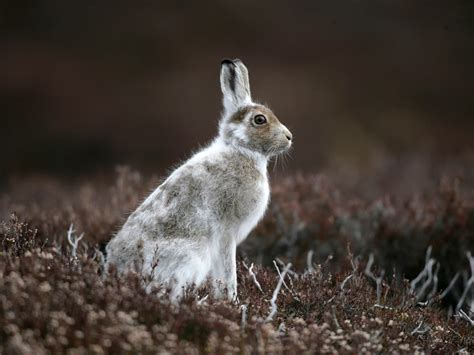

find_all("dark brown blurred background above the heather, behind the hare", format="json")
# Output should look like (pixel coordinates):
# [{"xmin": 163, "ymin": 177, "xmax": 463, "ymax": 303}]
[{"xmin": 0, "ymin": 0, "xmax": 474, "ymax": 189}]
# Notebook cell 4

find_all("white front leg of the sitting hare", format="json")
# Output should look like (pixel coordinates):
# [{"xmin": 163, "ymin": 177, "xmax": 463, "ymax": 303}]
[{"xmin": 213, "ymin": 239, "xmax": 237, "ymax": 300}]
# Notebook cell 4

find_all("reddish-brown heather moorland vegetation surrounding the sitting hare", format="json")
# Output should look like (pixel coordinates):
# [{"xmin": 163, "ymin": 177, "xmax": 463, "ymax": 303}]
[{"xmin": 0, "ymin": 168, "xmax": 474, "ymax": 353}]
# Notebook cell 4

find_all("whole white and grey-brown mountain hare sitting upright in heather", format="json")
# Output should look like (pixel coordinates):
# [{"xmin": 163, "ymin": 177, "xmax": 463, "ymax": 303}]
[{"xmin": 107, "ymin": 59, "xmax": 292, "ymax": 299}]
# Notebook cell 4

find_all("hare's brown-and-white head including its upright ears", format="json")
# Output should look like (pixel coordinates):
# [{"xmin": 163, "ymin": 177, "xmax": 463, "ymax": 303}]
[{"xmin": 219, "ymin": 59, "xmax": 292, "ymax": 157}]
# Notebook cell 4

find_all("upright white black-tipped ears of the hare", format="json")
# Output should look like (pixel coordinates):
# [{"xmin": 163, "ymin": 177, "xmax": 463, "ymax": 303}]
[{"xmin": 221, "ymin": 59, "xmax": 252, "ymax": 112}]
